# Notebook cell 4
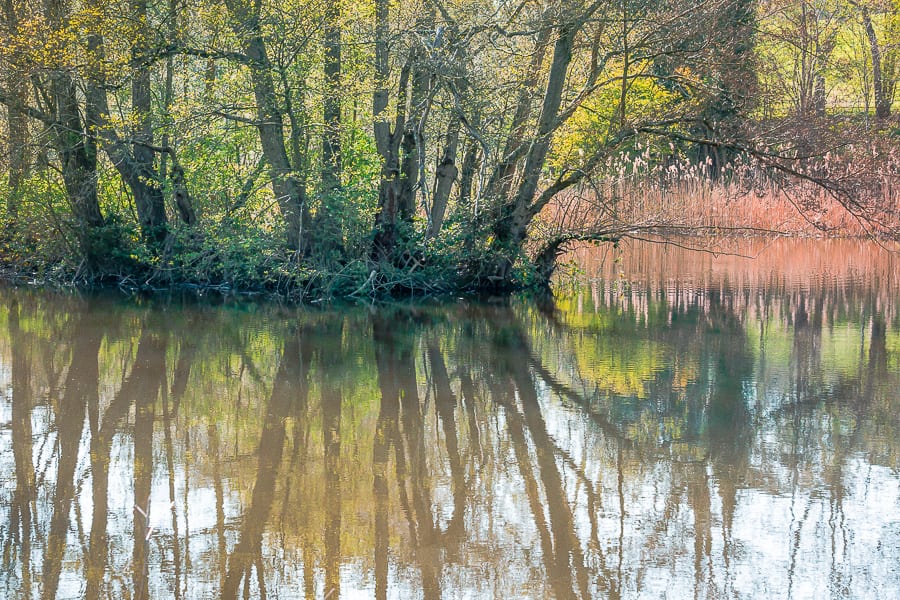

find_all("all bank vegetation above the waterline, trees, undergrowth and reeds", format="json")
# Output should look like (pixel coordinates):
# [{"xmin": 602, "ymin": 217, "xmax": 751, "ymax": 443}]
[{"xmin": 0, "ymin": 0, "xmax": 900, "ymax": 300}]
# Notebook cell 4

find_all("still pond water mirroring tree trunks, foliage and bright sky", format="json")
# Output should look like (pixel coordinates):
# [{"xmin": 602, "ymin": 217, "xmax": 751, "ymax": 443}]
[{"xmin": 0, "ymin": 241, "xmax": 900, "ymax": 600}]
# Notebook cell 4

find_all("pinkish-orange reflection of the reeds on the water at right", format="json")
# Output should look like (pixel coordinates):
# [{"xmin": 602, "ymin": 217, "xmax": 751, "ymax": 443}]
[{"xmin": 563, "ymin": 237, "xmax": 900, "ymax": 322}]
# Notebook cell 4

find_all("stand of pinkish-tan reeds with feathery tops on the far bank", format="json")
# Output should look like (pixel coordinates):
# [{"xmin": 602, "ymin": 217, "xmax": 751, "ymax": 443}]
[{"xmin": 542, "ymin": 143, "xmax": 900, "ymax": 239}]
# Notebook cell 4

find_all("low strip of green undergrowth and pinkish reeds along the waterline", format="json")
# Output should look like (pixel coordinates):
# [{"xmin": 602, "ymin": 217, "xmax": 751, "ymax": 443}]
[{"xmin": 0, "ymin": 149, "xmax": 900, "ymax": 303}]
